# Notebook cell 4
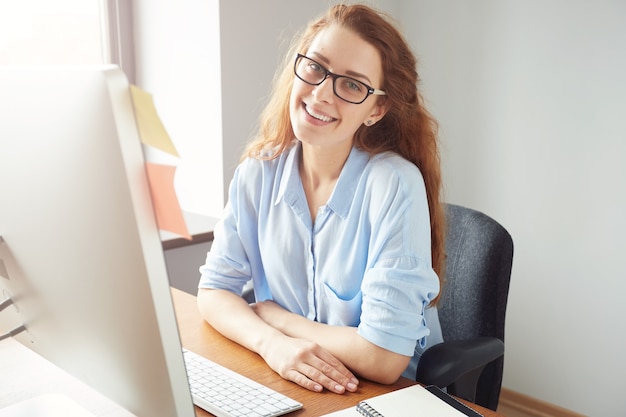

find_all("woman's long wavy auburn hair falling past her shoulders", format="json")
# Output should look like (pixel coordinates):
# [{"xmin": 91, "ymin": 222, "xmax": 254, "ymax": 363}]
[{"xmin": 243, "ymin": 4, "xmax": 446, "ymax": 304}]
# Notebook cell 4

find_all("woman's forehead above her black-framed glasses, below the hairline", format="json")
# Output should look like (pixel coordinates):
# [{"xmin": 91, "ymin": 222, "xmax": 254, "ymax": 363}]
[{"xmin": 306, "ymin": 25, "xmax": 383, "ymax": 84}]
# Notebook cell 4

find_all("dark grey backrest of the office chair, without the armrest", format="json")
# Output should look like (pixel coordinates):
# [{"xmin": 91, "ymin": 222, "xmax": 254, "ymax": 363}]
[{"xmin": 439, "ymin": 204, "xmax": 513, "ymax": 404}]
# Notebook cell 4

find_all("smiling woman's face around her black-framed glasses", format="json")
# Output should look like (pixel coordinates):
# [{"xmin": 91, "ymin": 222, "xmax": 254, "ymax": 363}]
[{"xmin": 290, "ymin": 26, "xmax": 385, "ymax": 151}]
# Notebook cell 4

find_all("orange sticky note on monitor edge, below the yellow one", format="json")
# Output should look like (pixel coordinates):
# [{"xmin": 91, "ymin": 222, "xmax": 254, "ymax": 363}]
[{"xmin": 146, "ymin": 162, "xmax": 191, "ymax": 240}]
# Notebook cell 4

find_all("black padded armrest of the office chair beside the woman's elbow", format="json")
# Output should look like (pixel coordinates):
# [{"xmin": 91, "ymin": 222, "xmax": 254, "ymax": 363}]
[{"xmin": 416, "ymin": 337, "xmax": 504, "ymax": 388}]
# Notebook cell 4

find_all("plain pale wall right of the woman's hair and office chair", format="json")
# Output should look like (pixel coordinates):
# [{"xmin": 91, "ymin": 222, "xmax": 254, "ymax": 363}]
[{"xmin": 400, "ymin": 0, "xmax": 626, "ymax": 417}]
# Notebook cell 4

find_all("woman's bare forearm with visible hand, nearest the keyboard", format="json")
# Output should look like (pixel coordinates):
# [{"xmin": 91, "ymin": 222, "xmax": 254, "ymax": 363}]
[{"xmin": 198, "ymin": 289, "xmax": 358, "ymax": 394}]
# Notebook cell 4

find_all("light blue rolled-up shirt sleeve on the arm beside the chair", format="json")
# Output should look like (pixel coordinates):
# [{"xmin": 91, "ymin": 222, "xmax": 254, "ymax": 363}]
[{"xmin": 358, "ymin": 154, "xmax": 440, "ymax": 356}]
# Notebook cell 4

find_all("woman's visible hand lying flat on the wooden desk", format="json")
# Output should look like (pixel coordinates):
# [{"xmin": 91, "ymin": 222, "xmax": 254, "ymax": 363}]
[{"xmin": 261, "ymin": 333, "xmax": 359, "ymax": 394}]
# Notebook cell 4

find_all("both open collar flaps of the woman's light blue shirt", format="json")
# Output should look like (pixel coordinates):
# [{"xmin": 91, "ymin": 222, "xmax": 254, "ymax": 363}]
[{"xmin": 274, "ymin": 142, "xmax": 370, "ymax": 218}]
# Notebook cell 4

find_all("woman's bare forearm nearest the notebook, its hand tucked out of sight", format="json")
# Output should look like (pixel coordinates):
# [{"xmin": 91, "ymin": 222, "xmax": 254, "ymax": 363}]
[{"xmin": 253, "ymin": 301, "xmax": 411, "ymax": 384}]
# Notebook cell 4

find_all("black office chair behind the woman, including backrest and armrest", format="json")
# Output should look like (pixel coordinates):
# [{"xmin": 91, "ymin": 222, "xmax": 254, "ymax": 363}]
[{"xmin": 416, "ymin": 204, "xmax": 513, "ymax": 410}]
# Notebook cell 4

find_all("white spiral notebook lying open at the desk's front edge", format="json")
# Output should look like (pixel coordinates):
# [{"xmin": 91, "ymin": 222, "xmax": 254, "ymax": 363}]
[{"xmin": 322, "ymin": 385, "xmax": 482, "ymax": 417}]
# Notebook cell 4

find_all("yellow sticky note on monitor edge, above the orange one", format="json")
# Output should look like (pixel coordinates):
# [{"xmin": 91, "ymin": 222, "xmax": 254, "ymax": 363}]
[{"xmin": 130, "ymin": 85, "xmax": 179, "ymax": 156}]
